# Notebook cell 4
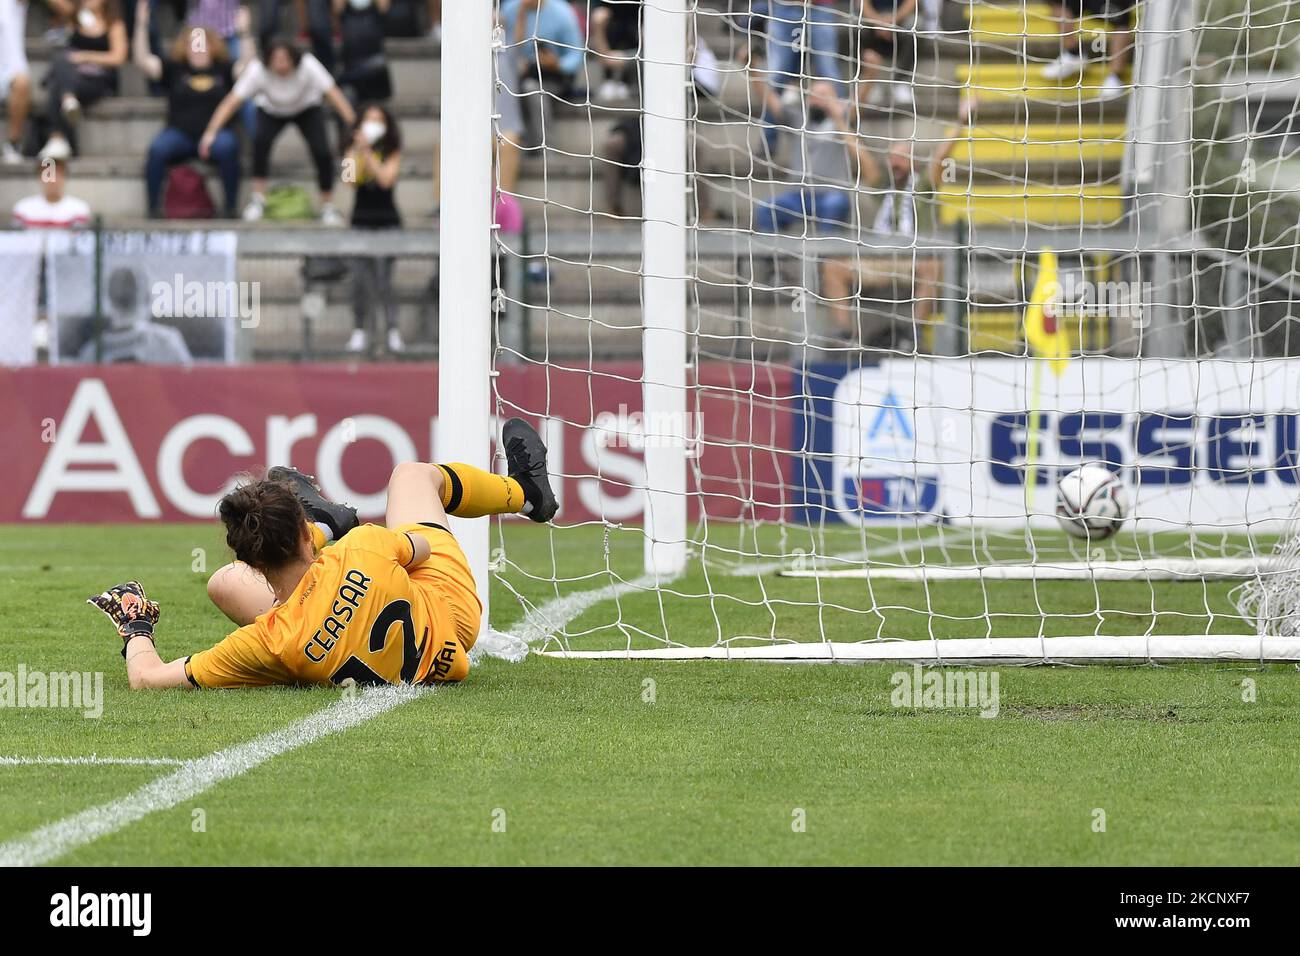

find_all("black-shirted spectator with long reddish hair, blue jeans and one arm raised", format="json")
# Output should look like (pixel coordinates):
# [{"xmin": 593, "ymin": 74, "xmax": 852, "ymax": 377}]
[{"xmin": 134, "ymin": 0, "xmax": 239, "ymax": 217}]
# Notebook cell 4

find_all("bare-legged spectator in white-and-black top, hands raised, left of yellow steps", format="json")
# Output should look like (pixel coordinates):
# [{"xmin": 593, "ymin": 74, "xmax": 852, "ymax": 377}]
[{"xmin": 822, "ymin": 139, "xmax": 956, "ymax": 350}]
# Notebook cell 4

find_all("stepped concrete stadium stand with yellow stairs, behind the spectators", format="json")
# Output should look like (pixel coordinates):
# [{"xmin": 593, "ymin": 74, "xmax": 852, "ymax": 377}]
[{"xmin": 0, "ymin": 0, "xmax": 1126, "ymax": 358}]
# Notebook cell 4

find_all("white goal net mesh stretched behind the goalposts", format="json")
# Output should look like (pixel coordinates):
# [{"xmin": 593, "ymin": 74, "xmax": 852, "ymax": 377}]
[{"xmin": 483, "ymin": 0, "xmax": 1300, "ymax": 661}]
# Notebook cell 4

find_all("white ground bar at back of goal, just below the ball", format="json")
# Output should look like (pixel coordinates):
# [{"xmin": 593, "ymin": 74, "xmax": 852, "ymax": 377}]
[{"xmin": 780, "ymin": 555, "xmax": 1281, "ymax": 581}]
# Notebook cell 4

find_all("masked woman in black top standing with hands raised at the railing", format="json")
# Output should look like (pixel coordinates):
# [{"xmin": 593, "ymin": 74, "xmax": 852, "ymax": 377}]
[{"xmin": 343, "ymin": 103, "xmax": 404, "ymax": 354}]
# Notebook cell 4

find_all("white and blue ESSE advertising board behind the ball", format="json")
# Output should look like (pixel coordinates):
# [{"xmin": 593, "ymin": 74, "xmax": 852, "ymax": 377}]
[{"xmin": 792, "ymin": 358, "xmax": 1300, "ymax": 532}]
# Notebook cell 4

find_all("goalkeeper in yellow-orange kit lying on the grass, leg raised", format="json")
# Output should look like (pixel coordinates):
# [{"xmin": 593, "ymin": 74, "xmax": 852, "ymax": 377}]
[{"xmin": 90, "ymin": 419, "xmax": 555, "ymax": 689}]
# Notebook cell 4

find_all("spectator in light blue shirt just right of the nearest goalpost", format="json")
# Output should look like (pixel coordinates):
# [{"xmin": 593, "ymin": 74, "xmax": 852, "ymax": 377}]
[{"xmin": 501, "ymin": 0, "xmax": 584, "ymax": 148}]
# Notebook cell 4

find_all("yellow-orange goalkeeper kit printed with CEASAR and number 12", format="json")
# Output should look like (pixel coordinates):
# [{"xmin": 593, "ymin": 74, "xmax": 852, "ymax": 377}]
[{"xmin": 186, "ymin": 524, "xmax": 477, "ymax": 687}]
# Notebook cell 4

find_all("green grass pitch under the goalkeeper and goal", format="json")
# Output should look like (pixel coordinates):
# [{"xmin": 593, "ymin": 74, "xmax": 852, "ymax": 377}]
[{"xmin": 0, "ymin": 523, "xmax": 1300, "ymax": 865}]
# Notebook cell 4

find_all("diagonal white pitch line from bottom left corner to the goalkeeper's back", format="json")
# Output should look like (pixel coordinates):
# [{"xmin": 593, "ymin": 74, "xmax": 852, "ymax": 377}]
[{"xmin": 0, "ymin": 685, "xmax": 433, "ymax": 866}]
